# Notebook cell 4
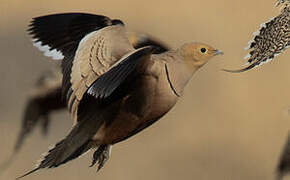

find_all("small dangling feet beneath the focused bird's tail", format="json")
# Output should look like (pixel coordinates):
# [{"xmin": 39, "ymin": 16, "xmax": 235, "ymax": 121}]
[{"xmin": 90, "ymin": 145, "xmax": 112, "ymax": 171}]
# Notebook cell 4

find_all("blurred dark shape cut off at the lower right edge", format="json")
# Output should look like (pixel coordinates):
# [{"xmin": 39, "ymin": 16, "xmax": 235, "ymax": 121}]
[{"xmin": 276, "ymin": 133, "xmax": 290, "ymax": 180}]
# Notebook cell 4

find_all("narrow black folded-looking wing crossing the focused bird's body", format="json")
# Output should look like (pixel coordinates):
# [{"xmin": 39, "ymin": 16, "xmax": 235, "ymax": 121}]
[{"xmin": 88, "ymin": 47, "xmax": 153, "ymax": 99}]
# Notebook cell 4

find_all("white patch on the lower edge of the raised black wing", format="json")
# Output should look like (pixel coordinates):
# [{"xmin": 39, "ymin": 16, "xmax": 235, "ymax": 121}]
[{"xmin": 32, "ymin": 39, "xmax": 64, "ymax": 60}]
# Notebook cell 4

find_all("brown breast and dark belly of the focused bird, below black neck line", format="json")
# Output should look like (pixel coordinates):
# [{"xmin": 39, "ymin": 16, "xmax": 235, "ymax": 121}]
[{"xmin": 95, "ymin": 67, "xmax": 178, "ymax": 144}]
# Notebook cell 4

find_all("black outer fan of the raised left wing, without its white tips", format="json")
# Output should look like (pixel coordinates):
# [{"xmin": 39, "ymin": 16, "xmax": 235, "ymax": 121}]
[{"xmin": 28, "ymin": 13, "xmax": 118, "ymax": 55}]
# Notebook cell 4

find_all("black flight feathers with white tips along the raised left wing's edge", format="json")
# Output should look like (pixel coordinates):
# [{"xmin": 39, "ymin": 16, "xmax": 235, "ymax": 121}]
[{"xmin": 28, "ymin": 13, "xmax": 123, "ymax": 100}]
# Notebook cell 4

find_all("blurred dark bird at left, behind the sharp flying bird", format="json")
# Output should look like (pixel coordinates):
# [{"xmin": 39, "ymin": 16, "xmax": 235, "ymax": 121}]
[{"xmin": 14, "ymin": 68, "xmax": 66, "ymax": 152}]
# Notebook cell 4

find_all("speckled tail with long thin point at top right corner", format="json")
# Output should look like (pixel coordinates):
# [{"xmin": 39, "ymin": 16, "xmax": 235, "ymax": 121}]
[{"xmin": 224, "ymin": 0, "xmax": 290, "ymax": 73}]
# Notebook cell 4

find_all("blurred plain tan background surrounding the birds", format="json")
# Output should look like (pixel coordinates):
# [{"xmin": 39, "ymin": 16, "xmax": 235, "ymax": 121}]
[{"xmin": 0, "ymin": 0, "xmax": 290, "ymax": 180}]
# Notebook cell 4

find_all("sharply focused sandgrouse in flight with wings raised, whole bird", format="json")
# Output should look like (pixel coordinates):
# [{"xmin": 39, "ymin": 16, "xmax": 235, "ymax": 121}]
[{"xmin": 19, "ymin": 13, "xmax": 222, "ymax": 178}]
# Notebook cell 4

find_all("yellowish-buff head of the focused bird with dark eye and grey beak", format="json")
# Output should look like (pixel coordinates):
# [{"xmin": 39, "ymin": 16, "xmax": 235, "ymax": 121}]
[{"xmin": 178, "ymin": 42, "xmax": 223, "ymax": 68}]
